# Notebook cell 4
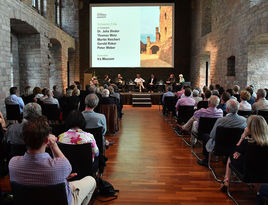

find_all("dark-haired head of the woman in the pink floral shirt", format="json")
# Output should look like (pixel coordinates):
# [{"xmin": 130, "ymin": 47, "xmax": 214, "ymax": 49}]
[{"xmin": 65, "ymin": 110, "xmax": 86, "ymax": 129}]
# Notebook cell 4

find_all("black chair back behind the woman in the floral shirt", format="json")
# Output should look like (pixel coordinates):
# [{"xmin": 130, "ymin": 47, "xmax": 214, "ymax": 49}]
[{"xmin": 58, "ymin": 143, "xmax": 93, "ymax": 181}]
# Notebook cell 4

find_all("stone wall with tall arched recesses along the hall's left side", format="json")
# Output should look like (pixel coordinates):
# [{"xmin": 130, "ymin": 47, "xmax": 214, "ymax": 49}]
[{"xmin": 0, "ymin": 0, "xmax": 76, "ymax": 113}]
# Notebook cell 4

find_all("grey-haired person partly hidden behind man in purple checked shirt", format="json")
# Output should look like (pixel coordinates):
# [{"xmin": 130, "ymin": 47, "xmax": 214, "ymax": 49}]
[{"xmin": 5, "ymin": 103, "xmax": 42, "ymax": 144}]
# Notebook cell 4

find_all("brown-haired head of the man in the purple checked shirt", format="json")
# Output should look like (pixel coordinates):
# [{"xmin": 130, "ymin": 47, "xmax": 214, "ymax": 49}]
[{"xmin": 22, "ymin": 116, "xmax": 51, "ymax": 150}]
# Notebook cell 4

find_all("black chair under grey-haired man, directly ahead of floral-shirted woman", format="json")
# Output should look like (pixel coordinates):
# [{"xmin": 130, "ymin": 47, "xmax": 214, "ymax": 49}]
[{"xmin": 85, "ymin": 127, "xmax": 106, "ymax": 174}]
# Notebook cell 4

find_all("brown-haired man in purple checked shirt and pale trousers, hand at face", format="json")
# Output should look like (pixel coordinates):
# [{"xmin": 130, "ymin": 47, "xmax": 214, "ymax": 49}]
[{"xmin": 9, "ymin": 117, "xmax": 96, "ymax": 204}]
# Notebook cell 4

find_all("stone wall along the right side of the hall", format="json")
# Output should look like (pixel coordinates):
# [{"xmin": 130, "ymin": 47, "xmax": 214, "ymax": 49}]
[{"xmin": 191, "ymin": 0, "xmax": 268, "ymax": 88}]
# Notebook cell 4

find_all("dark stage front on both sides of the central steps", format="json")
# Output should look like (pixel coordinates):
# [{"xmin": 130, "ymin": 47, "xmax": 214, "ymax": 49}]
[{"xmin": 120, "ymin": 92, "xmax": 163, "ymax": 105}]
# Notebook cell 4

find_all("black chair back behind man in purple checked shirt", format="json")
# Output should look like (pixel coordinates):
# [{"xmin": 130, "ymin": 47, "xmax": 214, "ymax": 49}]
[{"xmin": 11, "ymin": 182, "xmax": 68, "ymax": 205}]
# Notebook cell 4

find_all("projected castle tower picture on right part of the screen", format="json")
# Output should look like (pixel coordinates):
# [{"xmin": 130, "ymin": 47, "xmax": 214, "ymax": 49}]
[{"xmin": 140, "ymin": 6, "xmax": 173, "ymax": 67}]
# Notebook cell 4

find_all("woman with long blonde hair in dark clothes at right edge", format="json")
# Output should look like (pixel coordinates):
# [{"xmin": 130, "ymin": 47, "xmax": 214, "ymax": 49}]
[{"xmin": 221, "ymin": 115, "xmax": 268, "ymax": 192}]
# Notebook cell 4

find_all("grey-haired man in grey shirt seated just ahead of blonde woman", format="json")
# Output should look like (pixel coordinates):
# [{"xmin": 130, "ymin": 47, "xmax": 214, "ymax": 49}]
[{"xmin": 198, "ymin": 99, "xmax": 247, "ymax": 166}]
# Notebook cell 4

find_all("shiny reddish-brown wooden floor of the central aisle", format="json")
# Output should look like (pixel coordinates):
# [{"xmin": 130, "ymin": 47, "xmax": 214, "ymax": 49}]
[{"xmin": 95, "ymin": 106, "xmax": 254, "ymax": 205}]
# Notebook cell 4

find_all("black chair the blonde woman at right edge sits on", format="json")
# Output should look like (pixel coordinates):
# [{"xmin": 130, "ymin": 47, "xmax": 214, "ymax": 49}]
[{"xmin": 227, "ymin": 143, "xmax": 268, "ymax": 204}]
